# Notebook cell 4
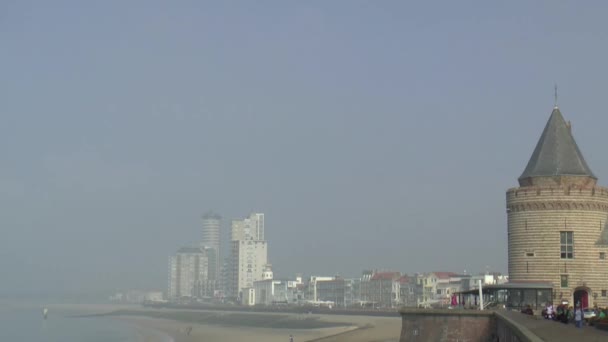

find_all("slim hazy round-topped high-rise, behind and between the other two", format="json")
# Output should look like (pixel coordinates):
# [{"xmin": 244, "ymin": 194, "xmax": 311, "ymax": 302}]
[{"xmin": 201, "ymin": 211, "xmax": 222, "ymax": 287}]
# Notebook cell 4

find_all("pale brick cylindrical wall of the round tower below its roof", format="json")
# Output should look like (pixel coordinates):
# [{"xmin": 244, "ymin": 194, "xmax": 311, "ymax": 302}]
[{"xmin": 507, "ymin": 187, "xmax": 608, "ymax": 307}]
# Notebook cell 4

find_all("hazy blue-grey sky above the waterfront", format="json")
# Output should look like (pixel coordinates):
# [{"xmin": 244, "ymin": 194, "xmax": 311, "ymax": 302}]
[{"xmin": 0, "ymin": 0, "xmax": 608, "ymax": 293}]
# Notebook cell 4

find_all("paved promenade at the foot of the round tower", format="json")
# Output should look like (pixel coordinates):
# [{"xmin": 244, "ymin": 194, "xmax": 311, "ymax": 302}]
[{"xmin": 501, "ymin": 311, "xmax": 608, "ymax": 342}]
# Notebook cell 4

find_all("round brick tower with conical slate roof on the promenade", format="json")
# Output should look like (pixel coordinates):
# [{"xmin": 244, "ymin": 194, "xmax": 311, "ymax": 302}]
[{"xmin": 506, "ymin": 106, "xmax": 608, "ymax": 307}]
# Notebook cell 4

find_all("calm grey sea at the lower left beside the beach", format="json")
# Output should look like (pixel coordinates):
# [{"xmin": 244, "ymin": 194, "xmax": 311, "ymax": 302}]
[{"xmin": 0, "ymin": 304, "xmax": 148, "ymax": 342}]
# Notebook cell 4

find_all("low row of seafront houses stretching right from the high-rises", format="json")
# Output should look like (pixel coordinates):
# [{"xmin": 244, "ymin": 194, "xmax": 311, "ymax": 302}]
[{"xmin": 242, "ymin": 271, "xmax": 507, "ymax": 308}]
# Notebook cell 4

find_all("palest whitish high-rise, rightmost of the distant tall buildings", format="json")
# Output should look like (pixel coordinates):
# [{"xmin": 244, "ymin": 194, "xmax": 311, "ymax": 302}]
[{"xmin": 227, "ymin": 213, "xmax": 268, "ymax": 297}]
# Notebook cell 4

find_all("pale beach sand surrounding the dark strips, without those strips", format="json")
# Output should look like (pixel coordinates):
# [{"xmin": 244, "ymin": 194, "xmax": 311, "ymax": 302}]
[{"xmin": 28, "ymin": 304, "xmax": 401, "ymax": 342}]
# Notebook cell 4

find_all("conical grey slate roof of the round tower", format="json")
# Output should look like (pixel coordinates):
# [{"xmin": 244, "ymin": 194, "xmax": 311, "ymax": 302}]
[{"xmin": 519, "ymin": 107, "xmax": 597, "ymax": 181}]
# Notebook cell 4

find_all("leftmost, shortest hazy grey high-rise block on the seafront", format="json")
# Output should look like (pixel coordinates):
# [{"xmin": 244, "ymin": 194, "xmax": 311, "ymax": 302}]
[{"xmin": 168, "ymin": 247, "xmax": 209, "ymax": 299}]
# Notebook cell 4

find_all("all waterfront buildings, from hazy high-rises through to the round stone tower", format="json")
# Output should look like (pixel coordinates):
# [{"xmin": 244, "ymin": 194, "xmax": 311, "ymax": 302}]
[{"xmin": 169, "ymin": 101, "xmax": 608, "ymax": 307}]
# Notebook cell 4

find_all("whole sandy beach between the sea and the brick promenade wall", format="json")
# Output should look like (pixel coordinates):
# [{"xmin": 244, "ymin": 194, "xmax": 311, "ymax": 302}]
[{"xmin": 33, "ymin": 304, "xmax": 401, "ymax": 342}]
